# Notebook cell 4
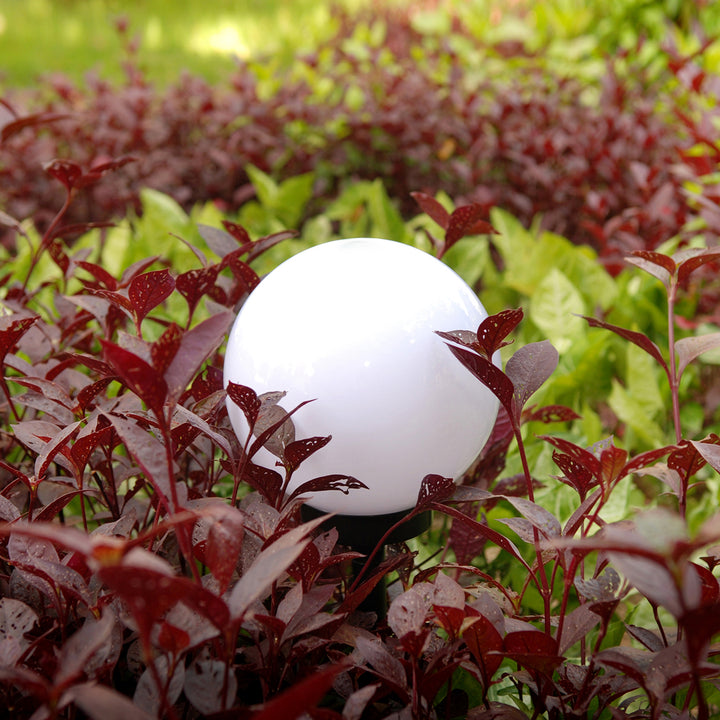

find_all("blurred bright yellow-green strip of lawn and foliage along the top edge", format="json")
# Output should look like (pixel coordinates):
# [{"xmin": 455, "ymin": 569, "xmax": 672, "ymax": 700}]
[{"xmin": 0, "ymin": 0, "xmax": 720, "ymax": 87}]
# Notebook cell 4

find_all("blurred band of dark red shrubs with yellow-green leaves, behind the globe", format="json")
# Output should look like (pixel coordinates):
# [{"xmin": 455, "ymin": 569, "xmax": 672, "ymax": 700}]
[{"xmin": 0, "ymin": 10, "xmax": 717, "ymax": 272}]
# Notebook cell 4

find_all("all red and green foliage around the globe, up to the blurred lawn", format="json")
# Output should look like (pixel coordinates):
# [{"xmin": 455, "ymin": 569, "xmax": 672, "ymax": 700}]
[{"xmin": 0, "ymin": 0, "xmax": 720, "ymax": 720}]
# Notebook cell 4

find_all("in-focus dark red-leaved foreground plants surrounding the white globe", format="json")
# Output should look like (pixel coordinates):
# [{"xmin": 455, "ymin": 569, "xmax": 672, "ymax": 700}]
[{"xmin": 0, "ymin": 136, "xmax": 720, "ymax": 720}]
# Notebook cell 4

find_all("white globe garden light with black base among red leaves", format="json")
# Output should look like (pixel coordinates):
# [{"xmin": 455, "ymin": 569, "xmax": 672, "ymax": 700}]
[{"xmin": 224, "ymin": 238, "xmax": 498, "ymax": 615}]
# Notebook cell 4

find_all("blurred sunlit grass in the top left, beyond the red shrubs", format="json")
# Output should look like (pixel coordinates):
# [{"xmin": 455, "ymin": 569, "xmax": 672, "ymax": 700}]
[{"xmin": 0, "ymin": 0, "xmax": 360, "ymax": 87}]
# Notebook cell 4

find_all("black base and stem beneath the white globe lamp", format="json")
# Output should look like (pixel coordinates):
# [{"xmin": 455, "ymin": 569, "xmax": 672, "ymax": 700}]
[{"xmin": 301, "ymin": 505, "xmax": 432, "ymax": 620}]
